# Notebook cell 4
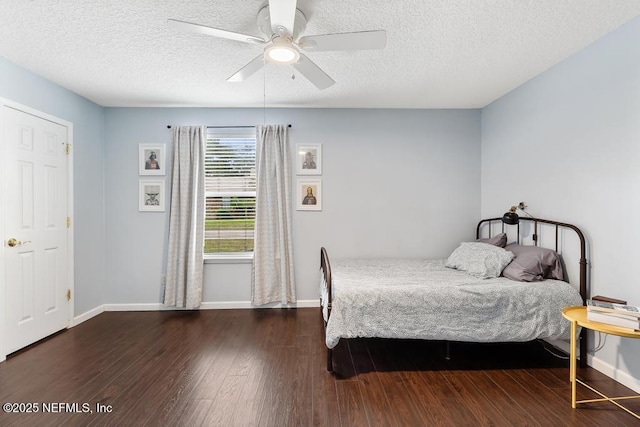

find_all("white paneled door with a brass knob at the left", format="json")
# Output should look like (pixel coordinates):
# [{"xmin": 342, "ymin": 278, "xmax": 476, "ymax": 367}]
[{"xmin": 0, "ymin": 103, "xmax": 72, "ymax": 360}]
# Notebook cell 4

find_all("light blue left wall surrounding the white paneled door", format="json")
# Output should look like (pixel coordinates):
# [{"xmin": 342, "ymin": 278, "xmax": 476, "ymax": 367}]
[{"xmin": 0, "ymin": 57, "xmax": 107, "ymax": 315}]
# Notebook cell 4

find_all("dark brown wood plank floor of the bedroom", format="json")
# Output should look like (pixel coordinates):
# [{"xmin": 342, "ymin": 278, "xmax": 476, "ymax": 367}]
[{"xmin": 0, "ymin": 309, "xmax": 640, "ymax": 426}]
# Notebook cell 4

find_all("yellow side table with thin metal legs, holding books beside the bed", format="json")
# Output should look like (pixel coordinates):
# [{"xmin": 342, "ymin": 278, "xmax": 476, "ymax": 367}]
[{"xmin": 562, "ymin": 306, "xmax": 640, "ymax": 419}]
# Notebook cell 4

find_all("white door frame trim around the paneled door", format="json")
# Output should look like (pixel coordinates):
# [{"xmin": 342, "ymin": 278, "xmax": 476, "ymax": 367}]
[{"xmin": 0, "ymin": 97, "xmax": 75, "ymax": 362}]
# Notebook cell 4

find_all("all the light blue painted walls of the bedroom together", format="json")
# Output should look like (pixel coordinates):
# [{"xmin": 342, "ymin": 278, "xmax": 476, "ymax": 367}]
[{"xmin": 0, "ymin": 13, "xmax": 640, "ymax": 389}]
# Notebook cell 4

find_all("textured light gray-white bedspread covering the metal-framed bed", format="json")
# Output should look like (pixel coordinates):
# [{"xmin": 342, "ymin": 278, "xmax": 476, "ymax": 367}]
[{"xmin": 326, "ymin": 259, "xmax": 582, "ymax": 348}]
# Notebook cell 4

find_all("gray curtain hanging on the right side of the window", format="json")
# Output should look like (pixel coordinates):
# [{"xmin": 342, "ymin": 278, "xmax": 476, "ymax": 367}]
[{"xmin": 251, "ymin": 125, "xmax": 296, "ymax": 305}]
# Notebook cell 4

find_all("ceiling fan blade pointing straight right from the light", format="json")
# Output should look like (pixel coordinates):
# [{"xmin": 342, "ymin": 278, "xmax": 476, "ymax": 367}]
[{"xmin": 298, "ymin": 30, "xmax": 387, "ymax": 51}]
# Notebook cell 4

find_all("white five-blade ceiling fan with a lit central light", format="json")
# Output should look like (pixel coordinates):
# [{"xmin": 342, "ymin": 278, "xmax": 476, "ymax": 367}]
[{"xmin": 168, "ymin": 0, "xmax": 387, "ymax": 90}]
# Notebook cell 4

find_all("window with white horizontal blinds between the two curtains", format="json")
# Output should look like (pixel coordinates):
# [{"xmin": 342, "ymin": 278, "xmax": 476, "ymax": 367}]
[{"xmin": 204, "ymin": 128, "xmax": 256, "ymax": 254}]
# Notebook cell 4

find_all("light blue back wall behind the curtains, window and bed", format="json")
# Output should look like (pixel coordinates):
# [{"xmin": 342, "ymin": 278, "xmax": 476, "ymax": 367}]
[{"xmin": 105, "ymin": 108, "xmax": 480, "ymax": 304}]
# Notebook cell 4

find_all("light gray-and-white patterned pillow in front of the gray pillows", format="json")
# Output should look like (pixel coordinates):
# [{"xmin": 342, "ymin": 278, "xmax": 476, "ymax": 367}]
[{"xmin": 445, "ymin": 242, "xmax": 514, "ymax": 279}]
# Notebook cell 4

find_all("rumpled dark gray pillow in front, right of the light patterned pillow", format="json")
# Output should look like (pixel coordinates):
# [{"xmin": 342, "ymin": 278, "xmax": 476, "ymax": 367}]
[{"xmin": 502, "ymin": 243, "xmax": 564, "ymax": 282}]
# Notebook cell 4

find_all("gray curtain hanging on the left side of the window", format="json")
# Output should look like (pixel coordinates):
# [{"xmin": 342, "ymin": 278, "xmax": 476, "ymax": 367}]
[{"xmin": 164, "ymin": 126, "xmax": 205, "ymax": 309}]
